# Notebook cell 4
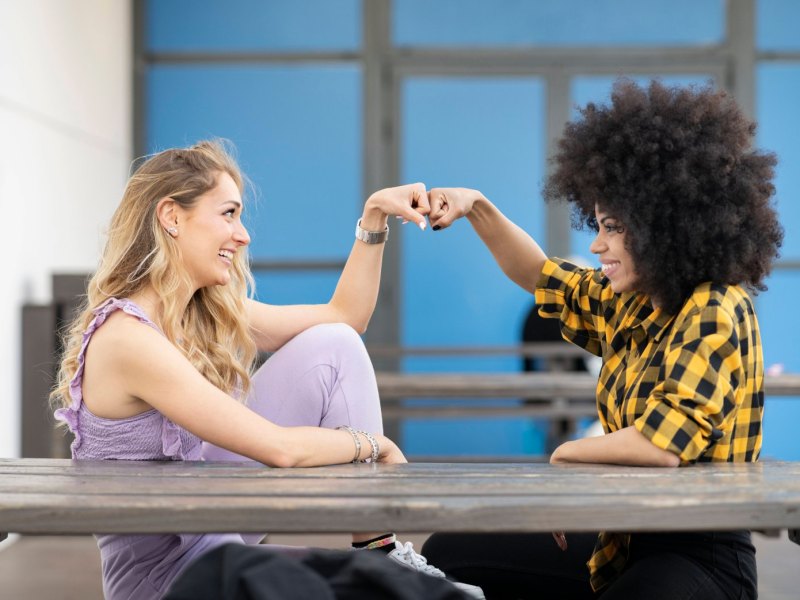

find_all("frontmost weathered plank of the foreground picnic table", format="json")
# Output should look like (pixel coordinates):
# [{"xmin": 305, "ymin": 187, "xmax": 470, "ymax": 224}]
[{"xmin": 0, "ymin": 494, "xmax": 798, "ymax": 534}]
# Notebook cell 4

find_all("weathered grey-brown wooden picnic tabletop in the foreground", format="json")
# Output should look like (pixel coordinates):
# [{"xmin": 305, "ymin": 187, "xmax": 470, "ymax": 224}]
[{"xmin": 0, "ymin": 459, "xmax": 800, "ymax": 534}]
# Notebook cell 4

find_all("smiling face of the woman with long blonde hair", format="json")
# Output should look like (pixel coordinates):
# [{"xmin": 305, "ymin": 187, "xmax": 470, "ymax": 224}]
[{"xmin": 174, "ymin": 173, "xmax": 250, "ymax": 289}]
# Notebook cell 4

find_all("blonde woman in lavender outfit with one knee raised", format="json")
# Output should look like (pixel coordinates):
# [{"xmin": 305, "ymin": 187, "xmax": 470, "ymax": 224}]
[{"xmin": 52, "ymin": 142, "xmax": 483, "ymax": 600}]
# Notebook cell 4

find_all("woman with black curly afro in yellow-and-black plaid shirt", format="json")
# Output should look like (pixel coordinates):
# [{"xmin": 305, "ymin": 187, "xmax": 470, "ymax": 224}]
[{"xmin": 423, "ymin": 80, "xmax": 783, "ymax": 600}]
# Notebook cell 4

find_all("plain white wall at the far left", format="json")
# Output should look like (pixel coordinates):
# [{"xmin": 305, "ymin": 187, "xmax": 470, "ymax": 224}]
[{"xmin": 0, "ymin": 0, "xmax": 133, "ymax": 457}]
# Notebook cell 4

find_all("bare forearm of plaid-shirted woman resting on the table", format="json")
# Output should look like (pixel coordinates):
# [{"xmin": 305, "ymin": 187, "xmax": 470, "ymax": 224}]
[{"xmin": 550, "ymin": 426, "xmax": 680, "ymax": 467}]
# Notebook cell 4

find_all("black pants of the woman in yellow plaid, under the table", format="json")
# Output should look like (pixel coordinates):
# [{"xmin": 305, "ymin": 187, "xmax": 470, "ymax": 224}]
[{"xmin": 422, "ymin": 531, "xmax": 758, "ymax": 600}]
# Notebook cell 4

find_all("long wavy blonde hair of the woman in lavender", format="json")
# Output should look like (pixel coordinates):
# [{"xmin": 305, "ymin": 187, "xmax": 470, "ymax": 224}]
[{"xmin": 50, "ymin": 140, "xmax": 256, "ymax": 407}]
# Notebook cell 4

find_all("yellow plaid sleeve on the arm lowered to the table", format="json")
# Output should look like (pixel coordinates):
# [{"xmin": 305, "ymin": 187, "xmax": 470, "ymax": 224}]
[{"xmin": 634, "ymin": 305, "xmax": 745, "ymax": 462}]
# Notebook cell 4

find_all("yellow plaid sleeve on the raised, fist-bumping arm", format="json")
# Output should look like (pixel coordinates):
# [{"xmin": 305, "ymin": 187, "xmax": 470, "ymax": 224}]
[{"xmin": 536, "ymin": 258, "xmax": 613, "ymax": 356}]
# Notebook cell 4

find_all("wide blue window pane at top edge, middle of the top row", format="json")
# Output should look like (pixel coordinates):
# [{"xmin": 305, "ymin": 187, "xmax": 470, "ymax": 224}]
[{"xmin": 392, "ymin": 0, "xmax": 725, "ymax": 47}]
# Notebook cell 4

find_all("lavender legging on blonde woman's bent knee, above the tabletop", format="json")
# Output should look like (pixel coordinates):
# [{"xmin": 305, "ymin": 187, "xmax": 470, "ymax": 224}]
[{"xmin": 203, "ymin": 323, "xmax": 383, "ymax": 460}]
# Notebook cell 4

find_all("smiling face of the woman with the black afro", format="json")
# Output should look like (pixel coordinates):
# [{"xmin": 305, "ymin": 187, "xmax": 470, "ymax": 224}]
[{"xmin": 589, "ymin": 206, "xmax": 639, "ymax": 294}]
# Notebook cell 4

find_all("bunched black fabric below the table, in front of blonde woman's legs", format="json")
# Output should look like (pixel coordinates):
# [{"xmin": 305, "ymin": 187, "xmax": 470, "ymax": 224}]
[{"xmin": 164, "ymin": 544, "xmax": 468, "ymax": 600}]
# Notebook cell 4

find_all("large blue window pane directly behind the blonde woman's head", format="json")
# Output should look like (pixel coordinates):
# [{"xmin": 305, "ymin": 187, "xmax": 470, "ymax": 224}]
[{"xmin": 147, "ymin": 65, "xmax": 362, "ymax": 259}]
